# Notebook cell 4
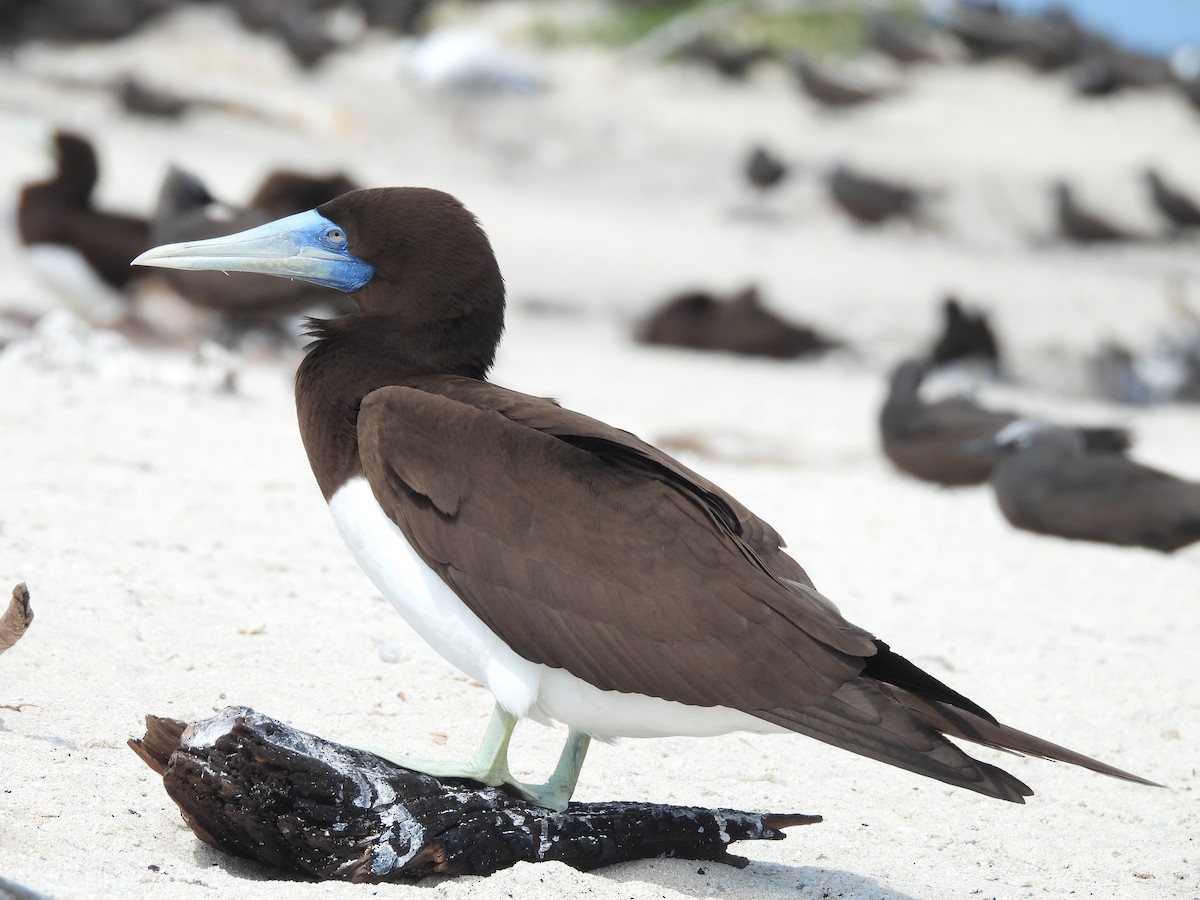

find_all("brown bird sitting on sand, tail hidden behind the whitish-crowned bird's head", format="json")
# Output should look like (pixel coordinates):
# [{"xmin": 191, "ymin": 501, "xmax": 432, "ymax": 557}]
[{"xmin": 880, "ymin": 360, "xmax": 1129, "ymax": 487}]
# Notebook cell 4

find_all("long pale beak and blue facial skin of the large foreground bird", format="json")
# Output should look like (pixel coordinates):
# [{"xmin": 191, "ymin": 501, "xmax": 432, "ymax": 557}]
[{"xmin": 132, "ymin": 210, "xmax": 374, "ymax": 294}]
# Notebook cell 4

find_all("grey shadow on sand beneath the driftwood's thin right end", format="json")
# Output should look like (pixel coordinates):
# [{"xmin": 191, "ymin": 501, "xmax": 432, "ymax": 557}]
[{"xmin": 592, "ymin": 859, "xmax": 914, "ymax": 900}]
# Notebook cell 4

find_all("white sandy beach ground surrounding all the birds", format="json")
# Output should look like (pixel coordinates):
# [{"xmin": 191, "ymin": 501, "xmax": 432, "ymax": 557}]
[{"xmin": 0, "ymin": 5, "xmax": 1200, "ymax": 899}]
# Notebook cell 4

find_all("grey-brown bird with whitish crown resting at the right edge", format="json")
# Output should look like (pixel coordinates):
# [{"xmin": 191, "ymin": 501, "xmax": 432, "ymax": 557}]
[{"xmin": 990, "ymin": 420, "xmax": 1200, "ymax": 553}]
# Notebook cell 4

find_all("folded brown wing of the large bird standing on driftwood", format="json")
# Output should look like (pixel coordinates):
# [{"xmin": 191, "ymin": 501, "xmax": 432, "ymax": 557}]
[{"xmin": 359, "ymin": 379, "xmax": 875, "ymax": 709}]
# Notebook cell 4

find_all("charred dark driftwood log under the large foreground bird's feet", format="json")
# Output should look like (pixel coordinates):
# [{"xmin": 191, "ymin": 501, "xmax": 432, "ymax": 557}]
[{"xmin": 130, "ymin": 707, "xmax": 821, "ymax": 882}]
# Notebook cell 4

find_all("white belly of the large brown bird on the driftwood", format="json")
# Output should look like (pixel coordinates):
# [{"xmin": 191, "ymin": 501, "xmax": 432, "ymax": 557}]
[{"xmin": 329, "ymin": 478, "xmax": 784, "ymax": 738}]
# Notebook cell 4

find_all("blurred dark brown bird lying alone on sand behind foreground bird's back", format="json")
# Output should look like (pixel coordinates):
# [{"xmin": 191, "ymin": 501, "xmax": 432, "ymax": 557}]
[{"xmin": 637, "ymin": 286, "xmax": 841, "ymax": 359}]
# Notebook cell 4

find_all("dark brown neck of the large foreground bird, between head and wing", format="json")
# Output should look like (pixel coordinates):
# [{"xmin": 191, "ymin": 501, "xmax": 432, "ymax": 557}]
[{"xmin": 296, "ymin": 314, "xmax": 499, "ymax": 502}]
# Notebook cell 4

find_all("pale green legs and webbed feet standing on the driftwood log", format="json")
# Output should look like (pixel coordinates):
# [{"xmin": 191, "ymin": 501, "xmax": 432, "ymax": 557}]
[{"xmin": 360, "ymin": 703, "xmax": 592, "ymax": 812}]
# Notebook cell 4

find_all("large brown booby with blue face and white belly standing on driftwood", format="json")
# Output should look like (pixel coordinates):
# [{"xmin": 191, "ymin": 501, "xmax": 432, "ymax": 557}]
[{"xmin": 136, "ymin": 187, "xmax": 1144, "ymax": 810}]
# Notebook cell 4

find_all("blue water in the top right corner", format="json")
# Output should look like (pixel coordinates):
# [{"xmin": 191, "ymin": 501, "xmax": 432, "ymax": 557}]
[{"xmin": 1003, "ymin": 0, "xmax": 1200, "ymax": 55}]
